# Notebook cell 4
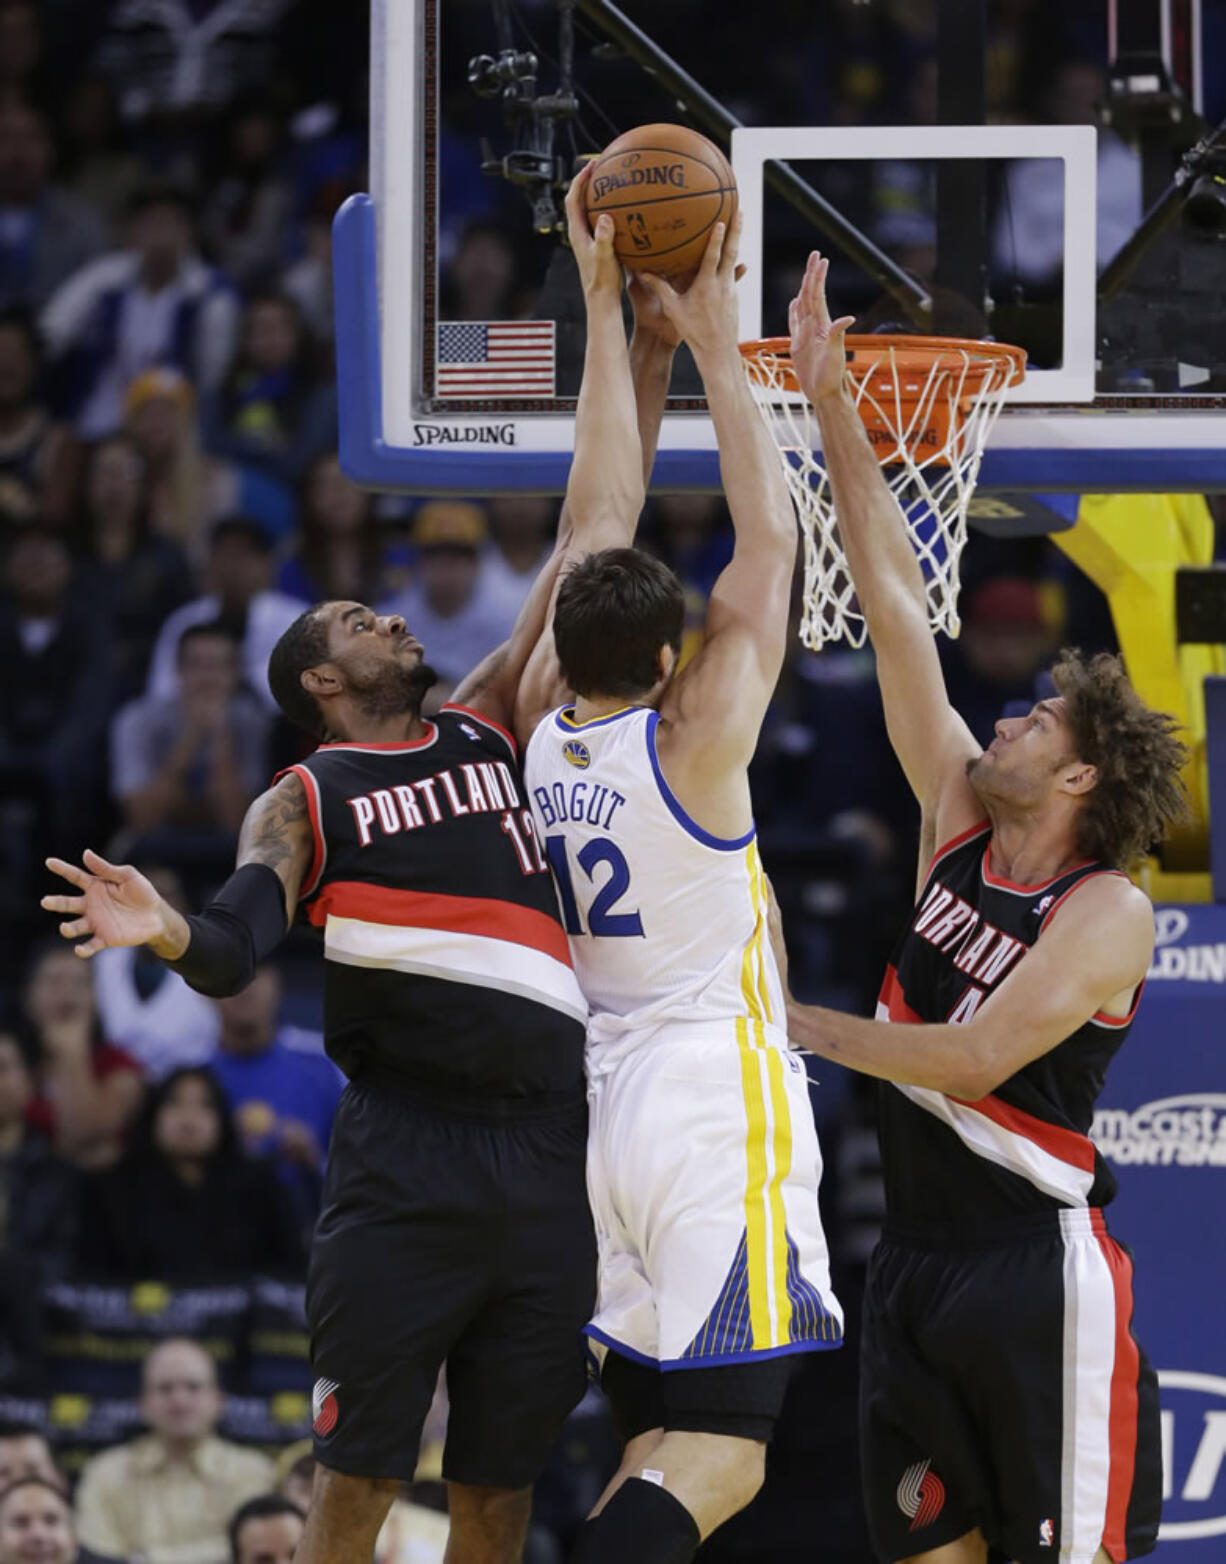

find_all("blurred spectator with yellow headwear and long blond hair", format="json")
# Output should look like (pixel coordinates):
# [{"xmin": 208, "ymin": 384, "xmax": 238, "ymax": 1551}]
[{"xmin": 124, "ymin": 366, "xmax": 238, "ymax": 557}]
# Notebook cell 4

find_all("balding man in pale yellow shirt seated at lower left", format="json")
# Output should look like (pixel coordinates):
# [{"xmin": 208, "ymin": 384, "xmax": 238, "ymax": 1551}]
[{"xmin": 77, "ymin": 1340, "xmax": 272, "ymax": 1564}]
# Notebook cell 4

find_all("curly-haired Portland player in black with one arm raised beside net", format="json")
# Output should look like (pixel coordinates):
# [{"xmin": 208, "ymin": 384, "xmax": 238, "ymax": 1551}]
[{"xmin": 775, "ymin": 261, "xmax": 1185, "ymax": 1564}]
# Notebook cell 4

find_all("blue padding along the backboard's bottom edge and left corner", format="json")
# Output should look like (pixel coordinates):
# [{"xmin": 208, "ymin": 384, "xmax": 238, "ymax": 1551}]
[{"xmin": 332, "ymin": 196, "xmax": 1226, "ymax": 494}]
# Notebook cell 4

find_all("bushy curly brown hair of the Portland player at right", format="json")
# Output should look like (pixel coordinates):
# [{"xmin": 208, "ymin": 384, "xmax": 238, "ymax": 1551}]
[{"xmin": 1051, "ymin": 647, "xmax": 1188, "ymax": 870}]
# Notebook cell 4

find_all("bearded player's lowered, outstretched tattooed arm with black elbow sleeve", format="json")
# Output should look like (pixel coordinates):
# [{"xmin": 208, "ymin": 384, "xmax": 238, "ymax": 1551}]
[{"xmin": 42, "ymin": 773, "xmax": 314, "ymax": 996}]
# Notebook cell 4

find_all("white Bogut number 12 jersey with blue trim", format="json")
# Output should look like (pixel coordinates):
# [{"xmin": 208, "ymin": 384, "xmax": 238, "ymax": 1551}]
[{"xmin": 524, "ymin": 707, "xmax": 783, "ymax": 1048}]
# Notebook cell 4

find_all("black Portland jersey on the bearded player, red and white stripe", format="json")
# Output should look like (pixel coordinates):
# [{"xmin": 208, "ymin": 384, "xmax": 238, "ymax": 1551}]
[{"xmin": 279, "ymin": 705, "xmax": 586, "ymax": 1098}]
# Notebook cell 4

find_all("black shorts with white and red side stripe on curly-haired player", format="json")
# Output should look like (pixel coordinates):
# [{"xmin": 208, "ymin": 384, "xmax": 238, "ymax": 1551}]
[{"xmin": 860, "ymin": 1209, "xmax": 1162, "ymax": 1564}]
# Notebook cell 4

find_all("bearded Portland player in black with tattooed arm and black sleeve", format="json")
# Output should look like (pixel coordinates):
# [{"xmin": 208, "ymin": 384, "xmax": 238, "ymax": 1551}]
[{"xmin": 42, "ymin": 243, "xmax": 677, "ymax": 1564}]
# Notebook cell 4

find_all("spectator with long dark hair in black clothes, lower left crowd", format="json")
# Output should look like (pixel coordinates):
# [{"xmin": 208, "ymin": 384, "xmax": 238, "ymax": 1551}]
[{"xmin": 77, "ymin": 1068, "xmax": 303, "ymax": 1282}]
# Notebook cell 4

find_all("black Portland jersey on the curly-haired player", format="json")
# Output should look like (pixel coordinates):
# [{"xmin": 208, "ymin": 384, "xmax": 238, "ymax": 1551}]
[{"xmin": 877, "ymin": 821, "xmax": 1140, "ymax": 1231}]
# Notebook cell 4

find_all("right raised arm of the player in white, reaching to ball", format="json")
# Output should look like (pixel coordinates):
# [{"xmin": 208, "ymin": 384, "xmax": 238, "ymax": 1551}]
[{"xmin": 647, "ymin": 224, "xmax": 798, "ymax": 777}]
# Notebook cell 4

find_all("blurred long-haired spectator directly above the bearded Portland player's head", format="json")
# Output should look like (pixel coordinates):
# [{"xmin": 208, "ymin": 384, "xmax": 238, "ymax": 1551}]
[{"xmin": 277, "ymin": 450, "xmax": 385, "ymax": 602}]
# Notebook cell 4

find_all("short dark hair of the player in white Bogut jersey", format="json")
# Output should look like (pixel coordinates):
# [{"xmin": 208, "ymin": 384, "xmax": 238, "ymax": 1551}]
[{"xmin": 554, "ymin": 549, "xmax": 685, "ymax": 696}]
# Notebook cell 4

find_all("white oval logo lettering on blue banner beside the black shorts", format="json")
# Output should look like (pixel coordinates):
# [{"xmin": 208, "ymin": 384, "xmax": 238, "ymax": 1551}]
[{"xmin": 1157, "ymin": 1369, "xmax": 1226, "ymax": 1542}]
